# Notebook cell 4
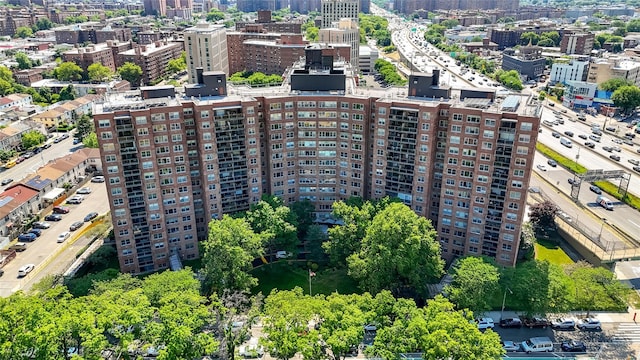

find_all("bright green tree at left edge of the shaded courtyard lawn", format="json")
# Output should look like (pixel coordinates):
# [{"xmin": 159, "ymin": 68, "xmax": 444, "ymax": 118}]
[{"xmin": 201, "ymin": 215, "xmax": 263, "ymax": 294}]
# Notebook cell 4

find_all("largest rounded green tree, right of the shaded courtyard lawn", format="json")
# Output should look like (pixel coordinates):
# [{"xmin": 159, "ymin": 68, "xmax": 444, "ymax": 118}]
[{"xmin": 347, "ymin": 203, "xmax": 443, "ymax": 297}]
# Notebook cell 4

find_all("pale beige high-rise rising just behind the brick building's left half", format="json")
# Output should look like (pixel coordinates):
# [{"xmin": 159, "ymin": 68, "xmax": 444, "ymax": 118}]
[{"xmin": 184, "ymin": 22, "xmax": 229, "ymax": 84}]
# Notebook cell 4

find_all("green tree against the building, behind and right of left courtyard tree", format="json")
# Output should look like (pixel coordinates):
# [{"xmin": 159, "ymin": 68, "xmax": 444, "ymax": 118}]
[{"xmin": 246, "ymin": 195, "xmax": 298, "ymax": 255}]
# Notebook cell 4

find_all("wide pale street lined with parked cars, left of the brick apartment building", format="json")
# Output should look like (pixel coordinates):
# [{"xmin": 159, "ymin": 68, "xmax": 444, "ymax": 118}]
[{"xmin": 0, "ymin": 183, "xmax": 109, "ymax": 296}]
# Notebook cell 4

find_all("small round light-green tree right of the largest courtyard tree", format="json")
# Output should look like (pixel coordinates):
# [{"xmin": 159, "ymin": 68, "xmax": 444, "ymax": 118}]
[{"xmin": 444, "ymin": 257, "xmax": 500, "ymax": 313}]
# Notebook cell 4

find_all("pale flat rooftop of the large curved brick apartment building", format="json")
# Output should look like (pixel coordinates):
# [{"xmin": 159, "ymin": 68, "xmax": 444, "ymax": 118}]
[{"xmin": 94, "ymin": 56, "xmax": 540, "ymax": 117}]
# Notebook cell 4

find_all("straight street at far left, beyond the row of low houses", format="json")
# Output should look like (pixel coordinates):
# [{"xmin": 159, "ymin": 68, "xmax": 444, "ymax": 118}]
[{"xmin": 0, "ymin": 136, "xmax": 82, "ymax": 187}]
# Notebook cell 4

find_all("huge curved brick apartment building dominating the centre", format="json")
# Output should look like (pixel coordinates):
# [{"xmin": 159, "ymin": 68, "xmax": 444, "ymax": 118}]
[{"xmin": 94, "ymin": 49, "xmax": 540, "ymax": 273}]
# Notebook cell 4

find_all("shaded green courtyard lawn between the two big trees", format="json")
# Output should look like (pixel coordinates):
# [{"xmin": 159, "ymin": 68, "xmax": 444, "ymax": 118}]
[{"xmin": 251, "ymin": 261, "xmax": 360, "ymax": 296}]
